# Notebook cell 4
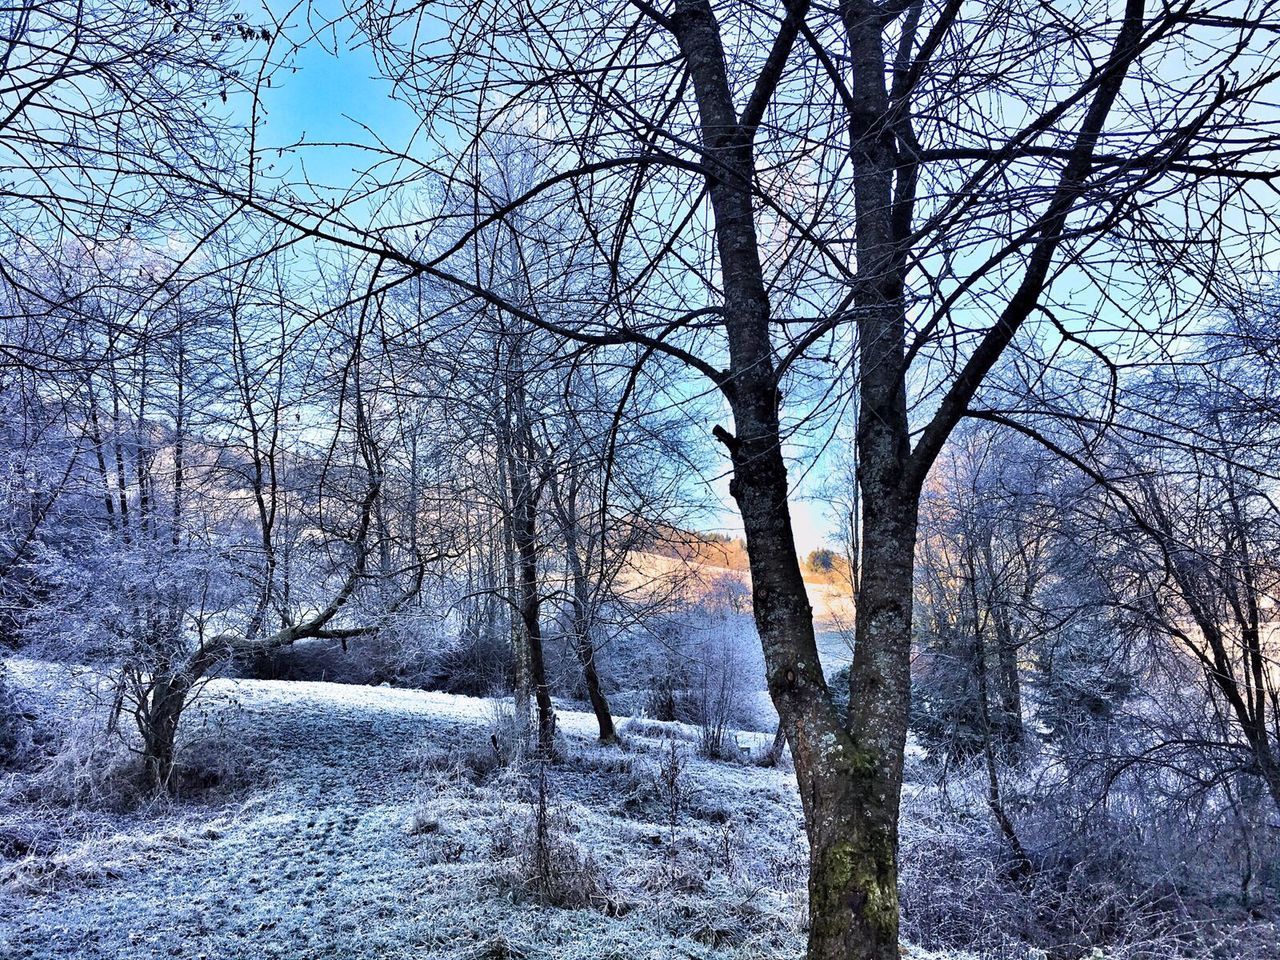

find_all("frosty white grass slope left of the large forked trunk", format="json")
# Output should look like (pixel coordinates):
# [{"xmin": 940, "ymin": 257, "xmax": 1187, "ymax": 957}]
[{"xmin": 0, "ymin": 663, "xmax": 839, "ymax": 960}]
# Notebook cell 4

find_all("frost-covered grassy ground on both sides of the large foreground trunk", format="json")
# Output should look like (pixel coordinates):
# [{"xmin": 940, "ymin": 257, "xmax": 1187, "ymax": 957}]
[{"xmin": 0, "ymin": 662, "xmax": 1280, "ymax": 960}]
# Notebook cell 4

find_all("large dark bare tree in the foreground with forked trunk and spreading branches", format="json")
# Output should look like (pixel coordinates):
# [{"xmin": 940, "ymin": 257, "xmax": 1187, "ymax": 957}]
[{"xmin": 217, "ymin": 0, "xmax": 1275, "ymax": 960}]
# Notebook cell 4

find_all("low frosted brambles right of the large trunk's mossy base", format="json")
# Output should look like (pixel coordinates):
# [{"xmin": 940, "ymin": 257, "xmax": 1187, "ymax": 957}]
[{"xmin": 899, "ymin": 764, "xmax": 1276, "ymax": 960}]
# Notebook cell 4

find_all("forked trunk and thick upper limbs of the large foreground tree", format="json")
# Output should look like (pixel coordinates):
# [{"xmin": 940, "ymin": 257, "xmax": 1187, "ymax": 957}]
[{"xmin": 667, "ymin": 0, "xmax": 1143, "ymax": 960}]
